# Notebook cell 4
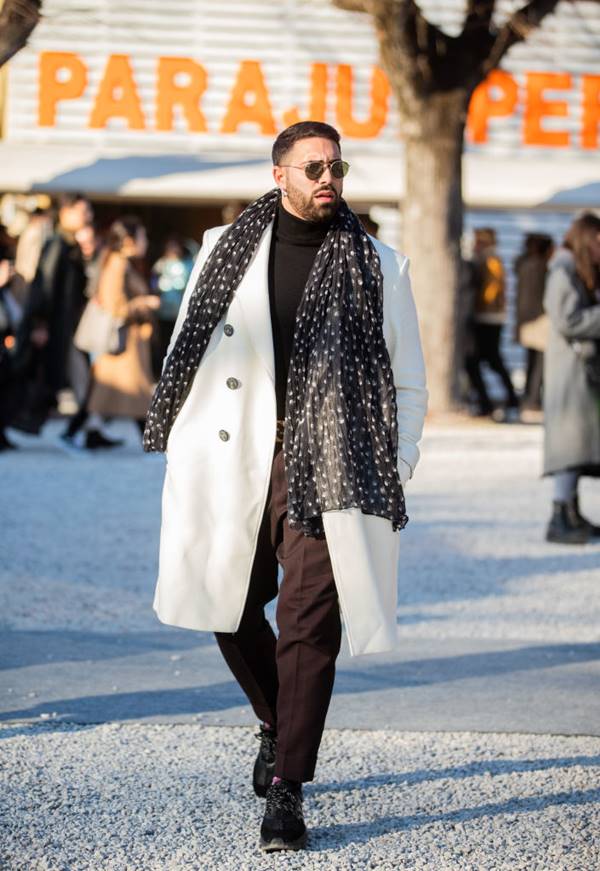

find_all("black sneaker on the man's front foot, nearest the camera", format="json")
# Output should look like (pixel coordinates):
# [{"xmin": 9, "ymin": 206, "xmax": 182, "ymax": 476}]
[{"xmin": 258, "ymin": 780, "xmax": 307, "ymax": 852}]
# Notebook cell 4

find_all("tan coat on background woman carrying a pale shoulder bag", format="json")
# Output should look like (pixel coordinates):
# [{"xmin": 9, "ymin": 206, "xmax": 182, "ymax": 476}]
[{"xmin": 88, "ymin": 253, "xmax": 153, "ymax": 419}]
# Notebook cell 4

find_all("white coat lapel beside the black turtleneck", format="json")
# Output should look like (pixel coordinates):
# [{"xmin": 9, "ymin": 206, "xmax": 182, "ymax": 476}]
[{"xmin": 235, "ymin": 222, "xmax": 275, "ymax": 383}]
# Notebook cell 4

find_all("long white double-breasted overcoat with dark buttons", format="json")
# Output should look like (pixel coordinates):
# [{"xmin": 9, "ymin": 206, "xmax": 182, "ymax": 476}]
[{"xmin": 154, "ymin": 224, "xmax": 427, "ymax": 656}]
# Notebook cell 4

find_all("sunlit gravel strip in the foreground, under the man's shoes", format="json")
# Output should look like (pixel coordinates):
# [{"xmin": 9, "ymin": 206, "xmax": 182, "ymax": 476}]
[{"xmin": 0, "ymin": 724, "xmax": 600, "ymax": 871}]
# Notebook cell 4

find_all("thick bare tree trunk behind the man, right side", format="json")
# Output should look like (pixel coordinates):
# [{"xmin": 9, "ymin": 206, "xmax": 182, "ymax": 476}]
[{"xmin": 402, "ymin": 92, "xmax": 468, "ymax": 413}]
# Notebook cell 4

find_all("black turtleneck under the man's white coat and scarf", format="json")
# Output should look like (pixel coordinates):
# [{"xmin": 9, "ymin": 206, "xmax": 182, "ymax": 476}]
[{"xmin": 269, "ymin": 203, "xmax": 331, "ymax": 420}]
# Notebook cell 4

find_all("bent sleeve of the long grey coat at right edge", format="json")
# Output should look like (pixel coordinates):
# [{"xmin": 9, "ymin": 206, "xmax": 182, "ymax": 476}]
[{"xmin": 544, "ymin": 266, "xmax": 600, "ymax": 340}]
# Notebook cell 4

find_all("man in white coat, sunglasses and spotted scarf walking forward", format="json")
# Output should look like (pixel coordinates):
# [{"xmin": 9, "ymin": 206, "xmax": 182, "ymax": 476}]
[{"xmin": 145, "ymin": 122, "xmax": 426, "ymax": 850}]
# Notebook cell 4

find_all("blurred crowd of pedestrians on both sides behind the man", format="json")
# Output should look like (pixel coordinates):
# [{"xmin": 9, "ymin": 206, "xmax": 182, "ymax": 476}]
[{"xmin": 0, "ymin": 194, "xmax": 600, "ymax": 544}]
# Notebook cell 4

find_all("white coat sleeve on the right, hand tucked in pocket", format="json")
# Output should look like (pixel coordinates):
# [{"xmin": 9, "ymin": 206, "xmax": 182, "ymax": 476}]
[{"xmin": 384, "ymin": 255, "xmax": 427, "ymax": 485}]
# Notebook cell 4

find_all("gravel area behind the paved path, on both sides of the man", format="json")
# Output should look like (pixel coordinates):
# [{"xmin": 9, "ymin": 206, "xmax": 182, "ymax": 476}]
[{"xmin": 0, "ymin": 422, "xmax": 600, "ymax": 643}]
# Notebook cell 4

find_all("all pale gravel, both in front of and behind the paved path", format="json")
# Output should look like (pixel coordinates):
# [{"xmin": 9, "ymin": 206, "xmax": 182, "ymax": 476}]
[{"xmin": 0, "ymin": 422, "xmax": 600, "ymax": 871}]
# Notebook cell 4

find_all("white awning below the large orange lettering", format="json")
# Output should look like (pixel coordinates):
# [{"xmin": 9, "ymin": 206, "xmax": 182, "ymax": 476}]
[{"xmin": 0, "ymin": 142, "xmax": 600, "ymax": 209}]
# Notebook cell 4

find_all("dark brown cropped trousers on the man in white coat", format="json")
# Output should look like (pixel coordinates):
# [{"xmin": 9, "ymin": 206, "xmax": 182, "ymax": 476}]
[{"xmin": 216, "ymin": 442, "xmax": 341, "ymax": 782}]
